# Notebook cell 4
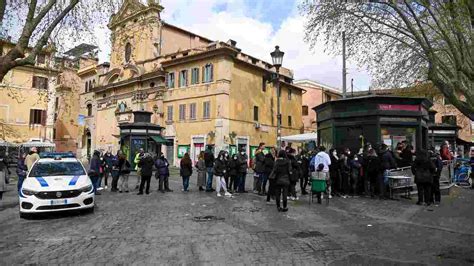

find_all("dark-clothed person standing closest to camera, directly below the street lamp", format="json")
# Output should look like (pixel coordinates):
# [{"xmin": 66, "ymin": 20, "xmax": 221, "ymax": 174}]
[{"xmin": 273, "ymin": 150, "xmax": 292, "ymax": 212}]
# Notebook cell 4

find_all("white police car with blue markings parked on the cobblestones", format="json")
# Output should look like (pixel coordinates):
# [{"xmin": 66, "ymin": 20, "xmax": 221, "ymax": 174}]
[{"xmin": 19, "ymin": 155, "xmax": 95, "ymax": 218}]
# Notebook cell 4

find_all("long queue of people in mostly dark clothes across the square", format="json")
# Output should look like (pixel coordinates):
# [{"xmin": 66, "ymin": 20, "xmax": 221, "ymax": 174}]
[{"xmin": 0, "ymin": 139, "xmax": 470, "ymax": 211}]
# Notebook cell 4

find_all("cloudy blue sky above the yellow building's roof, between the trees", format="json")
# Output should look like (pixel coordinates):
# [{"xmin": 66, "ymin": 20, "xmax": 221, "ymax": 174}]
[{"xmin": 95, "ymin": 0, "xmax": 370, "ymax": 91}]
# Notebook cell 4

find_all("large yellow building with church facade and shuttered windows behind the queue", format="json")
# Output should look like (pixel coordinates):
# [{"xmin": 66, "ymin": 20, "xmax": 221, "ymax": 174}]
[{"xmin": 78, "ymin": 0, "xmax": 303, "ymax": 164}]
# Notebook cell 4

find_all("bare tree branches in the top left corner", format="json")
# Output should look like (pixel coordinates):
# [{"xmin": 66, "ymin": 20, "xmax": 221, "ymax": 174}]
[{"xmin": 0, "ymin": 0, "xmax": 122, "ymax": 81}]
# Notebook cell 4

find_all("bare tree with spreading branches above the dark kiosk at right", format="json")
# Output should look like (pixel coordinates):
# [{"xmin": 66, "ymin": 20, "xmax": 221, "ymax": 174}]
[{"xmin": 300, "ymin": 0, "xmax": 474, "ymax": 120}]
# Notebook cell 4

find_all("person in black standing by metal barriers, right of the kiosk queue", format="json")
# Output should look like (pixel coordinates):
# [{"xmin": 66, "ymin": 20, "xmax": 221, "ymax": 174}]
[{"xmin": 411, "ymin": 150, "xmax": 436, "ymax": 206}]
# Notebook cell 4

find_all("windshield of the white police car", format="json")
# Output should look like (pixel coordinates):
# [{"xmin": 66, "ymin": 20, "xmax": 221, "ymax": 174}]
[{"xmin": 29, "ymin": 162, "xmax": 85, "ymax": 177}]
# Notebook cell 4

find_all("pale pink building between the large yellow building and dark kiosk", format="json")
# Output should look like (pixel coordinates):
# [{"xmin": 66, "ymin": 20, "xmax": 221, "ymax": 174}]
[{"xmin": 294, "ymin": 79, "xmax": 342, "ymax": 133}]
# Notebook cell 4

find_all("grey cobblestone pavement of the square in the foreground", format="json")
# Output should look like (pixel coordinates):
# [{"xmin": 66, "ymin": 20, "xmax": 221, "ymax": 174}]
[{"xmin": 0, "ymin": 172, "xmax": 474, "ymax": 265}]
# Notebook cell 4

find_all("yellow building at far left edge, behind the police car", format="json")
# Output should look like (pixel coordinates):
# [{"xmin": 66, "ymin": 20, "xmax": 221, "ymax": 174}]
[{"xmin": 0, "ymin": 40, "xmax": 59, "ymax": 147}]
